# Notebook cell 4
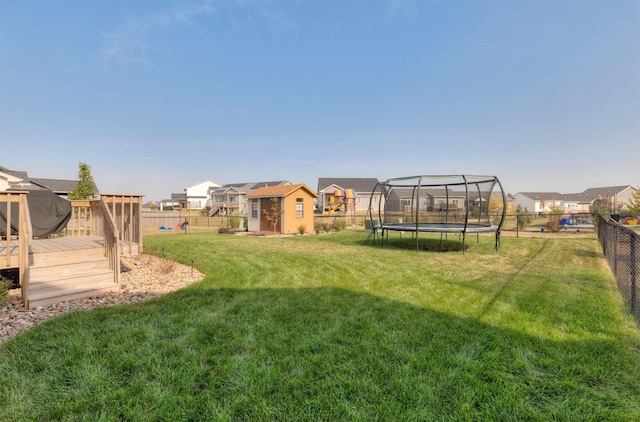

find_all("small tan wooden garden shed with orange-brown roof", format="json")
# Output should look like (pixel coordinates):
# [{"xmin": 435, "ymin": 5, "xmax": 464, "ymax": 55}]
[{"xmin": 246, "ymin": 183, "xmax": 318, "ymax": 234}]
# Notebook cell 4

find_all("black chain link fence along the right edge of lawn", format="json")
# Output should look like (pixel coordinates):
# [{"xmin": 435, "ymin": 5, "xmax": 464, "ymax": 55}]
[{"xmin": 597, "ymin": 216, "xmax": 640, "ymax": 326}]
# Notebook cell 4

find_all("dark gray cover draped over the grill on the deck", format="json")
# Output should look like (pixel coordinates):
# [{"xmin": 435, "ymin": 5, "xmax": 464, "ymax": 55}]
[{"xmin": 0, "ymin": 189, "xmax": 71, "ymax": 237}]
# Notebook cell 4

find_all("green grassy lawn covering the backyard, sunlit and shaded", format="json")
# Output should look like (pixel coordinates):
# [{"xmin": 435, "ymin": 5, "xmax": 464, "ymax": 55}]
[{"xmin": 0, "ymin": 231, "xmax": 640, "ymax": 421}]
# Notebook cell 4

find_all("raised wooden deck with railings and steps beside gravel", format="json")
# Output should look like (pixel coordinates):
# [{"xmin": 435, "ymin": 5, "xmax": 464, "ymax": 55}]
[{"xmin": 0, "ymin": 191, "xmax": 142, "ymax": 308}]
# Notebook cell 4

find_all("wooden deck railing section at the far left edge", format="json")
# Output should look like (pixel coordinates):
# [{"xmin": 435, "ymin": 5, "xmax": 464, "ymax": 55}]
[{"xmin": 0, "ymin": 191, "xmax": 33, "ymax": 306}]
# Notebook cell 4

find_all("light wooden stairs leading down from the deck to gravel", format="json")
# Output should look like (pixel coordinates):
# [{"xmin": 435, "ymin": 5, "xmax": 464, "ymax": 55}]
[{"xmin": 28, "ymin": 247, "xmax": 119, "ymax": 309}]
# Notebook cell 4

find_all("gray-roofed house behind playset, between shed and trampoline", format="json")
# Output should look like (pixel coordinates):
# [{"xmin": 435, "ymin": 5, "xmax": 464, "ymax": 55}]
[{"xmin": 316, "ymin": 177, "xmax": 381, "ymax": 214}]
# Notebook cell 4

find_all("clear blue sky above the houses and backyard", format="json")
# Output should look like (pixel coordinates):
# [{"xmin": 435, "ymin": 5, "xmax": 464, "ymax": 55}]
[{"xmin": 0, "ymin": 0, "xmax": 640, "ymax": 200}]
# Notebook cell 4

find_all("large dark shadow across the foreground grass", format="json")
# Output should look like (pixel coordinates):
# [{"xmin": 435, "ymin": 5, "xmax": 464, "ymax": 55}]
[{"xmin": 0, "ymin": 285, "xmax": 640, "ymax": 420}]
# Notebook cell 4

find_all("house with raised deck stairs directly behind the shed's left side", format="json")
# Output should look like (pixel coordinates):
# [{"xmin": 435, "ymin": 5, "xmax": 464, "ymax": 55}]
[{"xmin": 206, "ymin": 180, "xmax": 293, "ymax": 217}]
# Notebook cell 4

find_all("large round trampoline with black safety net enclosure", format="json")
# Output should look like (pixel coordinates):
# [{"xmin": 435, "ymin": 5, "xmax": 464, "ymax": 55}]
[{"xmin": 365, "ymin": 175, "xmax": 507, "ymax": 253}]
